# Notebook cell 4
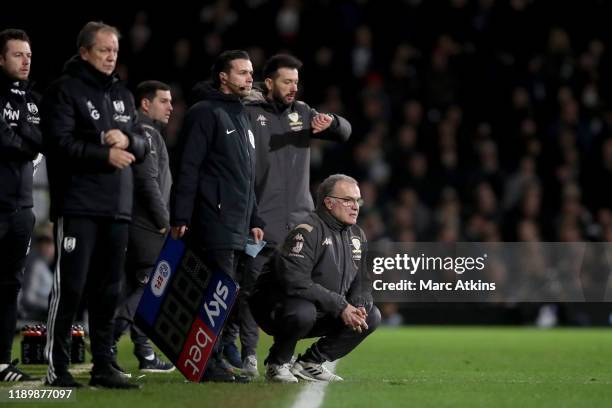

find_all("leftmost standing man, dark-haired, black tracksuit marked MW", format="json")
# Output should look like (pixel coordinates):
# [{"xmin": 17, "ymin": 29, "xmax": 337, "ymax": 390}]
[{"xmin": 0, "ymin": 29, "xmax": 42, "ymax": 382}]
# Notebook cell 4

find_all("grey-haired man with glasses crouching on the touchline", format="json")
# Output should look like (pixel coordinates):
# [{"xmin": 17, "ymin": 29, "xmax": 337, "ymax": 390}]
[{"xmin": 250, "ymin": 174, "xmax": 380, "ymax": 383}]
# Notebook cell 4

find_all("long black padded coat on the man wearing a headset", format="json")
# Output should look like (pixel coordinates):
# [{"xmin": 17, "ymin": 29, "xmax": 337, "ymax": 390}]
[{"xmin": 170, "ymin": 83, "xmax": 263, "ymax": 250}]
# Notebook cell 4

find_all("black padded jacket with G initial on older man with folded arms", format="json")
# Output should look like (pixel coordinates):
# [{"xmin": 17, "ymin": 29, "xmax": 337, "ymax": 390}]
[{"xmin": 41, "ymin": 56, "xmax": 149, "ymax": 220}]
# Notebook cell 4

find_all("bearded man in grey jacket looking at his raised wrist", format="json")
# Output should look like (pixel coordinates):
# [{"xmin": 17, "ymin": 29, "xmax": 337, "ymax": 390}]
[{"xmin": 224, "ymin": 54, "xmax": 351, "ymax": 375}]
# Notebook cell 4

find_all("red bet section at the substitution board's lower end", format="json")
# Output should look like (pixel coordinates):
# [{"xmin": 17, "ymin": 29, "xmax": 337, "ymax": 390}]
[{"xmin": 177, "ymin": 319, "xmax": 217, "ymax": 382}]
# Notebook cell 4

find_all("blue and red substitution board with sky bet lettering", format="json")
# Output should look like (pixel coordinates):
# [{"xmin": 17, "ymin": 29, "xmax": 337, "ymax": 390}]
[{"xmin": 134, "ymin": 237, "xmax": 238, "ymax": 382}]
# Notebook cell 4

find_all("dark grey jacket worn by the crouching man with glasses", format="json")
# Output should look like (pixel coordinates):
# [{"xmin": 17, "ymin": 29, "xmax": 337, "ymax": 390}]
[{"xmin": 256, "ymin": 210, "xmax": 372, "ymax": 316}]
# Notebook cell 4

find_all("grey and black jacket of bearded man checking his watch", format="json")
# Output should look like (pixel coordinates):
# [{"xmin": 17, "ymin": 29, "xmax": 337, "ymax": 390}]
[{"xmin": 246, "ymin": 88, "xmax": 351, "ymax": 245}]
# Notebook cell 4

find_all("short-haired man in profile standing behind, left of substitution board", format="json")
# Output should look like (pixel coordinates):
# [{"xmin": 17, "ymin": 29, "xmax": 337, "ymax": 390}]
[{"xmin": 113, "ymin": 81, "xmax": 174, "ymax": 373}]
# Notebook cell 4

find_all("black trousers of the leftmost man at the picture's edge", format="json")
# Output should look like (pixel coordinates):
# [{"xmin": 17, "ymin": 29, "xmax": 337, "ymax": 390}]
[{"xmin": 0, "ymin": 208, "xmax": 34, "ymax": 364}]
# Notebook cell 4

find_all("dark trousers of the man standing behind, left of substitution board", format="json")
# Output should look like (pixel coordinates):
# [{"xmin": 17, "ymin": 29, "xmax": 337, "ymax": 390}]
[{"xmin": 113, "ymin": 225, "xmax": 166, "ymax": 358}]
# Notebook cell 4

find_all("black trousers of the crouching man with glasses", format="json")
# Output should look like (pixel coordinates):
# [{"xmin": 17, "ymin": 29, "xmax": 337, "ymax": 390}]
[{"xmin": 249, "ymin": 288, "xmax": 381, "ymax": 364}]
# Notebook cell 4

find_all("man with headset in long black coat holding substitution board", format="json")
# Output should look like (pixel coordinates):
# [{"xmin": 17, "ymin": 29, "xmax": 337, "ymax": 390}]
[{"xmin": 170, "ymin": 50, "xmax": 263, "ymax": 381}]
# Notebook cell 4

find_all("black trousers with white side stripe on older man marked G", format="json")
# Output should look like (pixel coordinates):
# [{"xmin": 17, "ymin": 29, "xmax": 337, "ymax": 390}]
[{"xmin": 45, "ymin": 217, "xmax": 128, "ymax": 381}]
